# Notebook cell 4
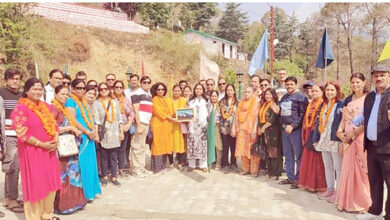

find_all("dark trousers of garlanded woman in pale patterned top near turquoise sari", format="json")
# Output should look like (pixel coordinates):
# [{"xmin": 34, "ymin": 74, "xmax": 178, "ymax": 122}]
[{"xmin": 100, "ymin": 147, "xmax": 119, "ymax": 177}]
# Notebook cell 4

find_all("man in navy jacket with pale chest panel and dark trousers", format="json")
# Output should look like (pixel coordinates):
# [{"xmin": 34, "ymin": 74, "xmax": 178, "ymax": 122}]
[{"xmin": 279, "ymin": 76, "xmax": 308, "ymax": 189}]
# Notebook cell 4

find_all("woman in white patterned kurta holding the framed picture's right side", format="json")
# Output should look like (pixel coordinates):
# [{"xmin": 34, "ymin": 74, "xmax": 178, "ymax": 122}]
[{"xmin": 187, "ymin": 83, "xmax": 209, "ymax": 172}]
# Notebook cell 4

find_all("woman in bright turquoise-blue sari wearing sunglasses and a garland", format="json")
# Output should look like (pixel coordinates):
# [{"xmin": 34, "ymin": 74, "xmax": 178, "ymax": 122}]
[{"xmin": 65, "ymin": 79, "xmax": 101, "ymax": 201}]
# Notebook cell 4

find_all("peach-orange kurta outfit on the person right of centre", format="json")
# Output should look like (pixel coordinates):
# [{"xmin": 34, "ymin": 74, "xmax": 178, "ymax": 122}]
[{"xmin": 235, "ymin": 97, "xmax": 260, "ymax": 158}]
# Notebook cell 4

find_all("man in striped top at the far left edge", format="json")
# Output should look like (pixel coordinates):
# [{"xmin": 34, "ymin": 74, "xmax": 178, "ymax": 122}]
[{"xmin": 0, "ymin": 68, "xmax": 24, "ymax": 212}]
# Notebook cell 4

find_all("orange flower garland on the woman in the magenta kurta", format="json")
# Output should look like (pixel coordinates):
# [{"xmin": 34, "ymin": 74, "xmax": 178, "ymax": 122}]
[{"xmin": 18, "ymin": 98, "xmax": 57, "ymax": 138}]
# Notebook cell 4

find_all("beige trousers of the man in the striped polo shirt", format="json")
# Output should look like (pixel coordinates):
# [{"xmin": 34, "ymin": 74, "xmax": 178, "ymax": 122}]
[{"xmin": 130, "ymin": 124, "xmax": 149, "ymax": 174}]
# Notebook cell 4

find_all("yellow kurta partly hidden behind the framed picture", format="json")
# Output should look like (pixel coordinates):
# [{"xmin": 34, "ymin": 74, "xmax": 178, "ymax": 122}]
[{"xmin": 172, "ymin": 97, "xmax": 187, "ymax": 153}]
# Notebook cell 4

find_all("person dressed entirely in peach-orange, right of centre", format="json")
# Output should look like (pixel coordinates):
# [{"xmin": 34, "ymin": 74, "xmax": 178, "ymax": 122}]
[{"xmin": 232, "ymin": 87, "xmax": 260, "ymax": 177}]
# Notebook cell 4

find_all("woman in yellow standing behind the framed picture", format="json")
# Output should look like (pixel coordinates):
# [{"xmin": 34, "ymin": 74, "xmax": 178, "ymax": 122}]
[{"xmin": 172, "ymin": 85, "xmax": 187, "ymax": 170}]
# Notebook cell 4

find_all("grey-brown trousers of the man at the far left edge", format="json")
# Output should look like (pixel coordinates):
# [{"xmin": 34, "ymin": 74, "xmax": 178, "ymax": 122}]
[{"xmin": 2, "ymin": 137, "xmax": 19, "ymax": 200}]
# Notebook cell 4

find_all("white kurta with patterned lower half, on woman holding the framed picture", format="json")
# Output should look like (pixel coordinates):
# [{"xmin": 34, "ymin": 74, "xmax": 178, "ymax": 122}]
[{"xmin": 187, "ymin": 98, "xmax": 208, "ymax": 160}]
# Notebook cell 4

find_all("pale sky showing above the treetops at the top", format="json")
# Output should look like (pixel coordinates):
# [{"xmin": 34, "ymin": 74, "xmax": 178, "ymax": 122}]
[{"xmin": 218, "ymin": 2, "xmax": 324, "ymax": 23}]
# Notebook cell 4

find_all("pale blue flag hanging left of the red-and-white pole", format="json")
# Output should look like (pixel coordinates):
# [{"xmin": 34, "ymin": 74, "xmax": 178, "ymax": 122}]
[{"xmin": 248, "ymin": 29, "xmax": 268, "ymax": 76}]
